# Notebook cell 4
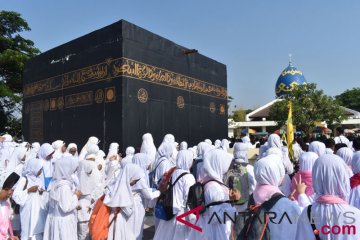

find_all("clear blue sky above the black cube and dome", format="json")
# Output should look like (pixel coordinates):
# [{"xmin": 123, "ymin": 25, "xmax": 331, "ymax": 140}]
[{"xmin": 0, "ymin": 0, "xmax": 360, "ymax": 108}]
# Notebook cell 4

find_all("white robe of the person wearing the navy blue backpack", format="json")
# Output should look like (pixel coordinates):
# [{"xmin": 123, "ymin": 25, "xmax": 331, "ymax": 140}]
[{"xmin": 154, "ymin": 170, "xmax": 195, "ymax": 240}]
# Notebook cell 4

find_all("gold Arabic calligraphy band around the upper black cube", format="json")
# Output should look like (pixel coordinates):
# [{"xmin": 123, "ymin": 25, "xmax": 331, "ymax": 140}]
[{"xmin": 23, "ymin": 58, "xmax": 227, "ymax": 99}]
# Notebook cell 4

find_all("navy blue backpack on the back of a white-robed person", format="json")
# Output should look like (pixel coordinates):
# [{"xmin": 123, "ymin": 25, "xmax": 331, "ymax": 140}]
[{"xmin": 155, "ymin": 172, "xmax": 188, "ymax": 221}]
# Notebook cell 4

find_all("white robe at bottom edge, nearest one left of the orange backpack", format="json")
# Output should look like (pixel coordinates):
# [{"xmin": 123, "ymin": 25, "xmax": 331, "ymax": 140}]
[{"xmin": 44, "ymin": 183, "xmax": 78, "ymax": 240}]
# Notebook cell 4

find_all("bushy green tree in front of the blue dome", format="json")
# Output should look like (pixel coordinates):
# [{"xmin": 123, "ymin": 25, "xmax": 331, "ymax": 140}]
[{"xmin": 270, "ymin": 83, "xmax": 345, "ymax": 134}]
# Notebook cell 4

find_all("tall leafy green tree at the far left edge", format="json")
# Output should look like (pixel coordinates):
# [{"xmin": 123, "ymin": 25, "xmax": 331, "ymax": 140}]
[{"xmin": 0, "ymin": 11, "xmax": 40, "ymax": 135}]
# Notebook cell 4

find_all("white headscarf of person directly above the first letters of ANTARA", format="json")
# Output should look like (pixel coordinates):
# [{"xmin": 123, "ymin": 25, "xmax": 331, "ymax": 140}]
[{"xmin": 204, "ymin": 149, "xmax": 232, "ymax": 182}]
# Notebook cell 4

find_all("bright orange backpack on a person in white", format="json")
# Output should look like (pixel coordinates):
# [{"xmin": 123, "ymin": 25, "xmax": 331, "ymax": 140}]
[{"xmin": 89, "ymin": 194, "xmax": 121, "ymax": 240}]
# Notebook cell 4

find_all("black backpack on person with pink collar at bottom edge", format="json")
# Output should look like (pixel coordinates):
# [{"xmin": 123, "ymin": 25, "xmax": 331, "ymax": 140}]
[{"xmin": 234, "ymin": 193, "xmax": 285, "ymax": 240}]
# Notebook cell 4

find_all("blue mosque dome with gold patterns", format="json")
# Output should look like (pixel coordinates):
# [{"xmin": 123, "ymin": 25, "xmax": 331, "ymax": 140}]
[{"xmin": 275, "ymin": 62, "xmax": 306, "ymax": 97}]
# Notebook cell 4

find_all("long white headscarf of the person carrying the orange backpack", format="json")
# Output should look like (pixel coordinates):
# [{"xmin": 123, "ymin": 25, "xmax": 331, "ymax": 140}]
[{"xmin": 104, "ymin": 163, "xmax": 147, "ymax": 208}]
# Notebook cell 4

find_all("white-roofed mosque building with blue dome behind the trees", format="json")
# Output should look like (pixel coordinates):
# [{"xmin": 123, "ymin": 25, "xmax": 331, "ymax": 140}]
[{"xmin": 228, "ymin": 60, "xmax": 360, "ymax": 137}]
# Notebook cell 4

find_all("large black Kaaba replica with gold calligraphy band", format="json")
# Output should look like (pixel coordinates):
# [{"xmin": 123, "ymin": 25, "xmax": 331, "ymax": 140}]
[{"xmin": 23, "ymin": 20, "xmax": 227, "ymax": 149}]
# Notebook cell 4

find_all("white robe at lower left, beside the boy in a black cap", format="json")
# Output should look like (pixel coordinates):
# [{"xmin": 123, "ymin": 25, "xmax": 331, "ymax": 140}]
[{"xmin": 12, "ymin": 177, "xmax": 47, "ymax": 240}]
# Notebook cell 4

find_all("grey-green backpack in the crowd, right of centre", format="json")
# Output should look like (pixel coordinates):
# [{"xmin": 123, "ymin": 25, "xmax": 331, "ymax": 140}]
[{"xmin": 224, "ymin": 163, "xmax": 250, "ymax": 205}]
